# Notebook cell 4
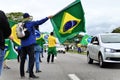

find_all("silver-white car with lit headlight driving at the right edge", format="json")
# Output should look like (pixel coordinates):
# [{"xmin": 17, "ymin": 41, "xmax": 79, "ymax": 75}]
[{"xmin": 87, "ymin": 33, "xmax": 120, "ymax": 67}]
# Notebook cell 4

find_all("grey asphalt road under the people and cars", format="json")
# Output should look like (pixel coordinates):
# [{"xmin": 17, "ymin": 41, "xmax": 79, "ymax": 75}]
[{"xmin": 0, "ymin": 53, "xmax": 120, "ymax": 80}]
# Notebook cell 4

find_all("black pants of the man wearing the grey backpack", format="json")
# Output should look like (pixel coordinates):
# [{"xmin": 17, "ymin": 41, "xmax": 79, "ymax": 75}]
[{"xmin": 20, "ymin": 45, "xmax": 35, "ymax": 77}]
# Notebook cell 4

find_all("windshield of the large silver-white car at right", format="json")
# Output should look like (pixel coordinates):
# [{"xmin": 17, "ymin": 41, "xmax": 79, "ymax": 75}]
[{"xmin": 101, "ymin": 35, "xmax": 120, "ymax": 43}]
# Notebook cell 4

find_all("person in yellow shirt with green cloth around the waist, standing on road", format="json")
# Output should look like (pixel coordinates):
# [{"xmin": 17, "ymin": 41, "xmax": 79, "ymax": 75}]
[{"xmin": 47, "ymin": 32, "xmax": 57, "ymax": 63}]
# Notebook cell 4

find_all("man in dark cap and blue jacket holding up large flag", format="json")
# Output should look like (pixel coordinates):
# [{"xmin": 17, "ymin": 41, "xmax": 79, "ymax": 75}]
[{"xmin": 20, "ymin": 13, "xmax": 52, "ymax": 78}]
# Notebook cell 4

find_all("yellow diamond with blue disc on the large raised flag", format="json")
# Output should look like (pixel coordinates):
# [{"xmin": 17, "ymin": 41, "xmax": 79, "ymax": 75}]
[{"xmin": 59, "ymin": 12, "xmax": 81, "ymax": 34}]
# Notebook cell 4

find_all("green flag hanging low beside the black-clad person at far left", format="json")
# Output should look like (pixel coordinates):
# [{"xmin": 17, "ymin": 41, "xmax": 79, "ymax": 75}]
[{"xmin": 4, "ymin": 39, "xmax": 17, "ymax": 59}]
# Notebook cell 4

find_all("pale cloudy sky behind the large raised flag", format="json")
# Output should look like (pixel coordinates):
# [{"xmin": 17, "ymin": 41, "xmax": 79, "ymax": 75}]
[{"xmin": 0, "ymin": 0, "xmax": 120, "ymax": 35}]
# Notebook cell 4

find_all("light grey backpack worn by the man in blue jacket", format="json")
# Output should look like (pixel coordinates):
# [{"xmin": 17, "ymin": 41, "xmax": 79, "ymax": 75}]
[{"xmin": 16, "ymin": 22, "xmax": 30, "ymax": 40}]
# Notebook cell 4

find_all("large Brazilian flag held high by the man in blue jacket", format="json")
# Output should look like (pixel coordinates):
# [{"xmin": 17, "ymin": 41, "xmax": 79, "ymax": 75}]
[{"xmin": 51, "ymin": 0, "xmax": 85, "ymax": 43}]
